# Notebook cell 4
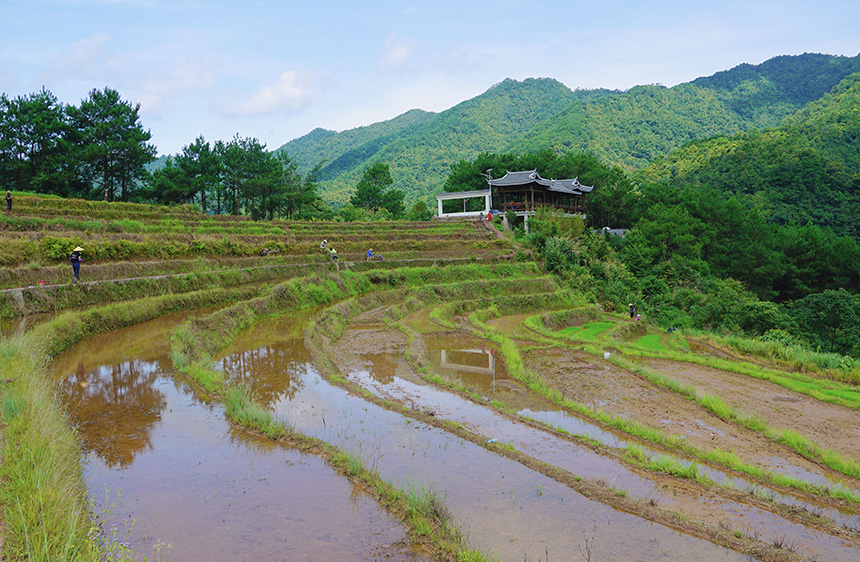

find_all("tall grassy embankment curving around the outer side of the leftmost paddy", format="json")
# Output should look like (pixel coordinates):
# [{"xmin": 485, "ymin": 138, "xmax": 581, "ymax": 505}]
[{"xmin": 0, "ymin": 288, "xmax": 258, "ymax": 562}]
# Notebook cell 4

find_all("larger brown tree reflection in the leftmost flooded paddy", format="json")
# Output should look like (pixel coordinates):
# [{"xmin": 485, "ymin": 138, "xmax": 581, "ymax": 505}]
[{"xmin": 62, "ymin": 361, "xmax": 167, "ymax": 468}]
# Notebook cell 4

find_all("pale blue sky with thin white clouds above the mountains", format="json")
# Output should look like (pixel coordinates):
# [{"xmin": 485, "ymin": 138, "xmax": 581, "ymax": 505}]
[{"xmin": 0, "ymin": 0, "xmax": 860, "ymax": 154}]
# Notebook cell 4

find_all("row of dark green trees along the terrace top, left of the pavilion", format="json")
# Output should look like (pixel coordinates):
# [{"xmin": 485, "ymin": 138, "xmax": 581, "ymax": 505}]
[{"xmin": 0, "ymin": 88, "xmax": 416, "ymax": 220}]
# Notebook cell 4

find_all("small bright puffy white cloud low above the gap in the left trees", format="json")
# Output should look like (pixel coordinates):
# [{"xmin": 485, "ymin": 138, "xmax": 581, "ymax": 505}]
[{"xmin": 221, "ymin": 70, "xmax": 316, "ymax": 116}]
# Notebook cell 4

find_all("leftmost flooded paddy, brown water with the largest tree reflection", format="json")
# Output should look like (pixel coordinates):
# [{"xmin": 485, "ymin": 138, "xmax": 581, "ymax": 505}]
[{"xmin": 56, "ymin": 315, "xmax": 425, "ymax": 562}]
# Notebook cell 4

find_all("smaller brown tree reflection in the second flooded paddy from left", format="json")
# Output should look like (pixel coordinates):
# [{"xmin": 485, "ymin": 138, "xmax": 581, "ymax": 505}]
[{"xmin": 221, "ymin": 342, "xmax": 311, "ymax": 405}]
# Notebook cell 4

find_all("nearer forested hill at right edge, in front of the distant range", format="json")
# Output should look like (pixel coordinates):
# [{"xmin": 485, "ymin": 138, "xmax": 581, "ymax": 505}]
[{"xmin": 641, "ymin": 73, "xmax": 860, "ymax": 240}]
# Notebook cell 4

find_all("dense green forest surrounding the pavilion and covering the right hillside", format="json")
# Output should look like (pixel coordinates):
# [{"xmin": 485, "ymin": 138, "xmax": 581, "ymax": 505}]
[{"xmin": 434, "ymin": 61, "xmax": 860, "ymax": 358}]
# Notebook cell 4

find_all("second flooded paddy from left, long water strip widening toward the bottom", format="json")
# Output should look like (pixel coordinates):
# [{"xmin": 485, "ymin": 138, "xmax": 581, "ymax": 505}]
[{"xmin": 220, "ymin": 318, "xmax": 747, "ymax": 560}]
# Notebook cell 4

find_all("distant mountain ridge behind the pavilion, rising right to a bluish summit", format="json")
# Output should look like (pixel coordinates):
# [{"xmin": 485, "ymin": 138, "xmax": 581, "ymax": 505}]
[{"xmin": 507, "ymin": 54, "xmax": 860, "ymax": 169}]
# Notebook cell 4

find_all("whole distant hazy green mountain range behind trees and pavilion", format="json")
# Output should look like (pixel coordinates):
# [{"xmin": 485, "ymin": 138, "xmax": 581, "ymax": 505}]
[{"xmin": 279, "ymin": 54, "xmax": 860, "ymax": 203}]
